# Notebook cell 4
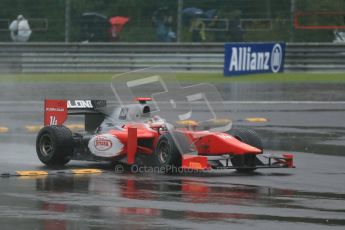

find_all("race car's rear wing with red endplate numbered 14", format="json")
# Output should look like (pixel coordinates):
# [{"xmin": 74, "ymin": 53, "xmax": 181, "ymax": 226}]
[{"xmin": 44, "ymin": 99, "xmax": 107, "ymax": 131}]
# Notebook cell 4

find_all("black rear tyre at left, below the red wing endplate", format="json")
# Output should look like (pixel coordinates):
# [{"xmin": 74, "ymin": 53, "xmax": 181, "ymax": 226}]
[{"xmin": 36, "ymin": 125, "xmax": 73, "ymax": 166}]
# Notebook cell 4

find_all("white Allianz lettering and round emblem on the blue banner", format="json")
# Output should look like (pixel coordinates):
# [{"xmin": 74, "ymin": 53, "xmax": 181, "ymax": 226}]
[{"xmin": 229, "ymin": 43, "xmax": 283, "ymax": 73}]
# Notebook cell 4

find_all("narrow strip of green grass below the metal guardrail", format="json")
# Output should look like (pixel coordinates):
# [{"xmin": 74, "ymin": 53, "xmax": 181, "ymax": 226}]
[{"xmin": 0, "ymin": 73, "xmax": 345, "ymax": 83}]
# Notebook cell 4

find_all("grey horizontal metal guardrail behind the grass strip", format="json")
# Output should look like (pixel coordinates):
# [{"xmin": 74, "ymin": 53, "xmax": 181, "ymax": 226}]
[{"xmin": 0, "ymin": 43, "xmax": 345, "ymax": 73}]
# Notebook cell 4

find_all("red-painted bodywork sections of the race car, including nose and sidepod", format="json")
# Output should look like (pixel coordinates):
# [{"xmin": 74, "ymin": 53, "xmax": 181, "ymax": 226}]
[{"xmin": 44, "ymin": 98, "xmax": 294, "ymax": 170}]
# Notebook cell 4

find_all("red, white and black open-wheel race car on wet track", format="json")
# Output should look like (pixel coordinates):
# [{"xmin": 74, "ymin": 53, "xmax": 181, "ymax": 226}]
[{"xmin": 36, "ymin": 98, "xmax": 294, "ymax": 173}]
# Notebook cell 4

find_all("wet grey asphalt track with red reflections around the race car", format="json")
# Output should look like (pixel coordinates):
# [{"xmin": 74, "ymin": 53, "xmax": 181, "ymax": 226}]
[{"xmin": 0, "ymin": 83, "xmax": 345, "ymax": 229}]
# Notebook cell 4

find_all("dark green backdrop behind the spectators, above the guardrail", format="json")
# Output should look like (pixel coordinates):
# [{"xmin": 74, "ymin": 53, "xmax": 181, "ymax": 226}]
[{"xmin": 0, "ymin": 0, "xmax": 345, "ymax": 42}]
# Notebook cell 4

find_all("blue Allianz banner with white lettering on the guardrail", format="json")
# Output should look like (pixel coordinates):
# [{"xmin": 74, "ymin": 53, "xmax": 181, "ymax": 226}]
[{"xmin": 224, "ymin": 43, "xmax": 285, "ymax": 76}]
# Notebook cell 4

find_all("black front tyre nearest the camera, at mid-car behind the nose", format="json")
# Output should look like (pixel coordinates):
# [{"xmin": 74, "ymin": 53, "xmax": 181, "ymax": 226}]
[{"xmin": 154, "ymin": 132, "xmax": 190, "ymax": 173}]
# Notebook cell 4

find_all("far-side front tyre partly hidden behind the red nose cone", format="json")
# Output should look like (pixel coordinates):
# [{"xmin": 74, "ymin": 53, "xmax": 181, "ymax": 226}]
[{"xmin": 227, "ymin": 129, "xmax": 263, "ymax": 173}]
